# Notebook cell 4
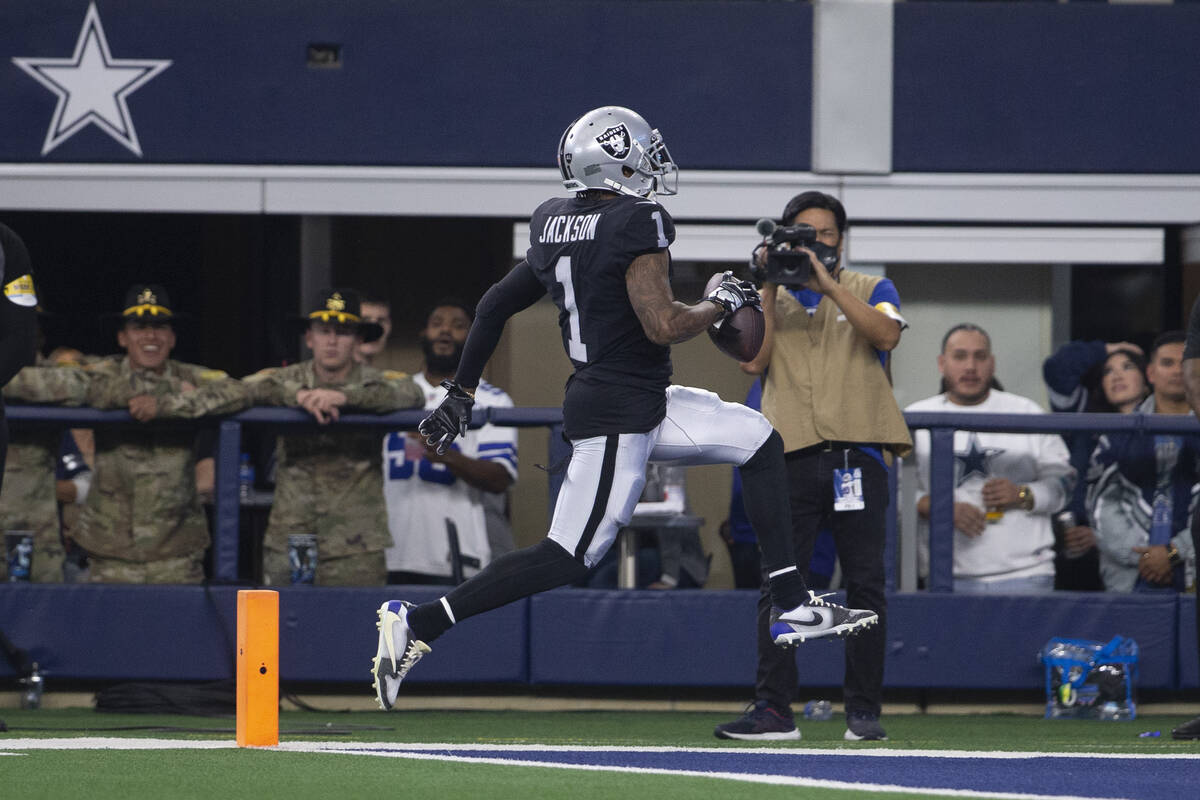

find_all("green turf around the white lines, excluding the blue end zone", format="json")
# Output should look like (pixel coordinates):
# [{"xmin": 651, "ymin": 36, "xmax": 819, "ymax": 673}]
[{"xmin": 0, "ymin": 710, "xmax": 1200, "ymax": 800}]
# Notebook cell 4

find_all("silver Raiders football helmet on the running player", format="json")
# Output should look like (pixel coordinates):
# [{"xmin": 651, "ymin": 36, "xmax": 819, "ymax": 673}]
[{"xmin": 558, "ymin": 106, "xmax": 679, "ymax": 197}]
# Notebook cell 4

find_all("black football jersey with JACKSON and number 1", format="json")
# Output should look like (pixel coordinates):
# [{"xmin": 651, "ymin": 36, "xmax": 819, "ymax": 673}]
[{"xmin": 526, "ymin": 194, "xmax": 674, "ymax": 439}]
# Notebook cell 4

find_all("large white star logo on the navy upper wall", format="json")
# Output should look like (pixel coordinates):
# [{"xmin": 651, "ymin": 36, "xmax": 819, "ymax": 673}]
[{"xmin": 12, "ymin": 2, "xmax": 170, "ymax": 156}]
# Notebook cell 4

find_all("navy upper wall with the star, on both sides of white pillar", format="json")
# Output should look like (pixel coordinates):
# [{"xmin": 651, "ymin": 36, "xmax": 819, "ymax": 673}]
[{"xmin": 0, "ymin": 0, "xmax": 1200, "ymax": 174}]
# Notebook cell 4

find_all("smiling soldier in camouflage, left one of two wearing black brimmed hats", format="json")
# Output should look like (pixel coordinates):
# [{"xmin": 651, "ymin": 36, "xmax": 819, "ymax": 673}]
[{"xmin": 76, "ymin": 284, "xmax": 250, "ymax": 583}]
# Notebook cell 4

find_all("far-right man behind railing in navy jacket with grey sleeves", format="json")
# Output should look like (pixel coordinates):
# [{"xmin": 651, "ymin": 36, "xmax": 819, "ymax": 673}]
[{"xmin": 1087, "ymin": 331, "xmax": 1200, "ymax": 591}]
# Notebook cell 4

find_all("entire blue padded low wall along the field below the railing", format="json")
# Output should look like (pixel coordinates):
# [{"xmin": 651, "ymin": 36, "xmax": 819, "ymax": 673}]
[{"xmin": 0, "ymin": 584, "xmax": 1200, "ymax": 690}]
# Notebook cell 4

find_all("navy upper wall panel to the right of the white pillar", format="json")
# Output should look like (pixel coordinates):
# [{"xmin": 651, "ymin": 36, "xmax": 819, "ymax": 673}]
[{"xmin": 893, "ymin": 2, "xmax": 1200, "ymax": 173}]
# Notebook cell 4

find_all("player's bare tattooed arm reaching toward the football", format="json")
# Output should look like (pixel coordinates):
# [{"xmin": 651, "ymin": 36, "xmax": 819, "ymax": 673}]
[{"xmin": 625, "ymin": 251, "xmax": 725, "ymax": 344}]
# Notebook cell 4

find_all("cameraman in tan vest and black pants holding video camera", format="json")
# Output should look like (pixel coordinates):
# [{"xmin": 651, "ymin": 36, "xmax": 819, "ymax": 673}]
[{"xmin": 715, "ymin": 192, "xmax": 912, "ymax": 740}]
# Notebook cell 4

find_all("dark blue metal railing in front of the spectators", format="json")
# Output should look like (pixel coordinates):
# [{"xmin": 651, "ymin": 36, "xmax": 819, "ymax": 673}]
[{"xmin": 7, "ymin": 405, "xmax": 1200, "ymax": 593}]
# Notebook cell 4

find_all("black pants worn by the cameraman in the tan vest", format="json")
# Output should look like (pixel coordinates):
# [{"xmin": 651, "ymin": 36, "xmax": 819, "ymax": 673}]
[{"xmin": 755, "ymin": 450, "xmax": 890, "ymax": 715}]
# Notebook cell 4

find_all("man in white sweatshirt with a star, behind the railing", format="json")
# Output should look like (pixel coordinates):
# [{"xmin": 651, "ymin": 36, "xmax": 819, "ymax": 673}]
[{"xmin": 905, "ymin": 323, "xmax": 1075, "ymax": 594}]
